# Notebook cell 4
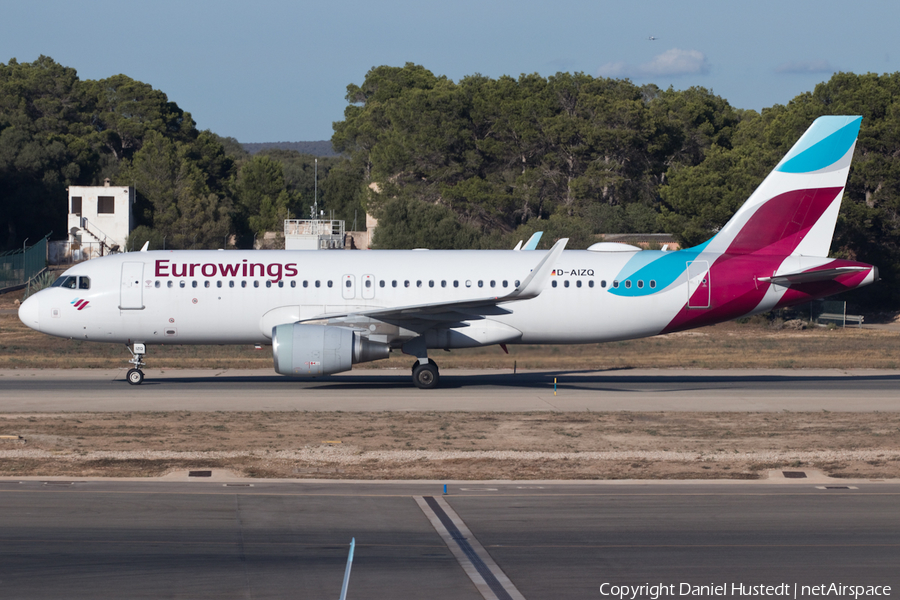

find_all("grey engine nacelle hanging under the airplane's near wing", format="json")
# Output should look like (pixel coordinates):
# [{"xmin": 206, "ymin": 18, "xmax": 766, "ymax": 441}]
[{"xmin": 272, "ymin": 323, "xmax": 391, "ymax": 377}]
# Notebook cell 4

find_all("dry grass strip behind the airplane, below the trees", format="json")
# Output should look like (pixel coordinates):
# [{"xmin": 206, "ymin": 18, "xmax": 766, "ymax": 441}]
[{"xmin": 0, "ymin": 315, "xmax": 900, "ymax": 369}]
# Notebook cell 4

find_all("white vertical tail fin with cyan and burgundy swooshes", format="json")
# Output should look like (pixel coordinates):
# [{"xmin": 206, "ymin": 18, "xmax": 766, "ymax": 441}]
[{"xmin": 704, "ymin": 116, "xmax": 862, "ymax": 257}]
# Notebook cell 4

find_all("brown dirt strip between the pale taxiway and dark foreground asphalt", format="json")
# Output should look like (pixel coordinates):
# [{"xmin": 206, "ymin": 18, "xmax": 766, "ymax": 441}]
[{"xmin": 0, "ymin": 412, "xmax": 900, "ymax": 480}]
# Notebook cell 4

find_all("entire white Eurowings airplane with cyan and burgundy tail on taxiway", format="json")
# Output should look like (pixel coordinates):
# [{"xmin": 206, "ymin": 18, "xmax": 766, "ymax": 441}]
[{"xmin": 19, "ymin": 116, "xmax": 878, "ymax": 388}]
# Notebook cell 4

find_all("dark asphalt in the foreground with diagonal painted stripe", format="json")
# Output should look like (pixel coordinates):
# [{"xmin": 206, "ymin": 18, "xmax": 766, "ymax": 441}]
[{"xmin": 0, "ymin": 479, "xmax": 900, "ymax": 600}]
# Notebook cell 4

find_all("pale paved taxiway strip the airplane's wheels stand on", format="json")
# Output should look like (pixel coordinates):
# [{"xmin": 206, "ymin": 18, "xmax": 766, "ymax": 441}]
[{"xmin": 0, "ymin": 369, "xmax": 900, "ymax": 413}]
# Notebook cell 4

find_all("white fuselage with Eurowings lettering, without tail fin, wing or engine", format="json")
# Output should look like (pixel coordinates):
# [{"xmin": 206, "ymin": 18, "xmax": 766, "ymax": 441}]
[{"xmin": 26, "ymin": 250, "xmax": 874, "ymax": 347}]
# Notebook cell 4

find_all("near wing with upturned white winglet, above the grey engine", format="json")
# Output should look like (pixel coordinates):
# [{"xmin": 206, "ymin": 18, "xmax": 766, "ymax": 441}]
[{"xmin": 309, "ymin": 238, "xmax": 569, "ymax": 331}]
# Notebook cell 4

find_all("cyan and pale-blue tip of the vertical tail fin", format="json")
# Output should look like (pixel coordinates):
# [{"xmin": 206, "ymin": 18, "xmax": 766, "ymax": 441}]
[{"xmin": 778, "ymin": 117, "xmax": 862, "ymax": 173}]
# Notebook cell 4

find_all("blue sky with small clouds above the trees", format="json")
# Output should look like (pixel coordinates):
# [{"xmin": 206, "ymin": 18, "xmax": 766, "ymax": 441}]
[{"xmin": 0, "ymin": 0, "xmax": 900, "ymax": 142}]
